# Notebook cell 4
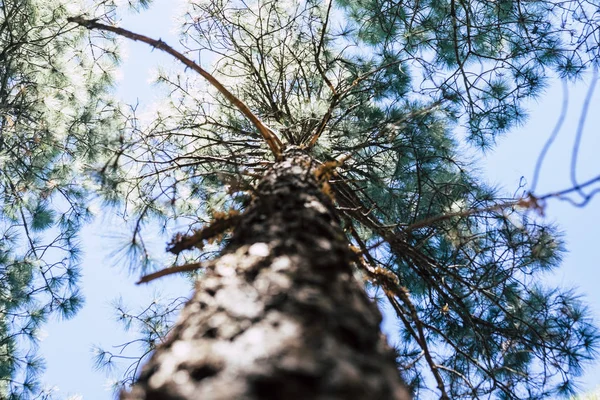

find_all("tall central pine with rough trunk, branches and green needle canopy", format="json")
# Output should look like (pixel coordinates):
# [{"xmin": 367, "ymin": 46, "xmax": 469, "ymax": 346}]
[{"xmin": 8, "ymin": 0, "xmax": 598, "ymax": 399}]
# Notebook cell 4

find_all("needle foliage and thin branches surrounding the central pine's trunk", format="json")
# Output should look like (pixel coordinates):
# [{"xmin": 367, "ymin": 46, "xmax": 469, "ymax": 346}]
[{"xmin": 82, "ymin": 0, "xmax": 599, "ymax": 399}]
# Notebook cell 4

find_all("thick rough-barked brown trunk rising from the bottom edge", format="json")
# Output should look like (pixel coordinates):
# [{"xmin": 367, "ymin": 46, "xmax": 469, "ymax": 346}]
[{"xmin": 122, "ymin": 153, "xmax": 410, "ymax": 400}]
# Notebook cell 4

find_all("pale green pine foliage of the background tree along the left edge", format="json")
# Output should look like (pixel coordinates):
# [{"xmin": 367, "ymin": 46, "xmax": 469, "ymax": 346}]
[{"xmin": 0, "ymin": 0, "xmax": 122, "ymax": 399}]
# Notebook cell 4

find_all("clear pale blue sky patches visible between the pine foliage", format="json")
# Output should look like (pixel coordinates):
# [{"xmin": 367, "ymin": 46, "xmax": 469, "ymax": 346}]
[{"xmin": 41, "ymin": 0, "xmax": 600, "ymax": 400}]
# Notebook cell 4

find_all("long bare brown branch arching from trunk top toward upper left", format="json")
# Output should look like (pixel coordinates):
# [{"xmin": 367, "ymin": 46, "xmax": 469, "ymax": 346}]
[{"xmin": 67, "ymin": 16, "xmax": 283, "ymax": 159}]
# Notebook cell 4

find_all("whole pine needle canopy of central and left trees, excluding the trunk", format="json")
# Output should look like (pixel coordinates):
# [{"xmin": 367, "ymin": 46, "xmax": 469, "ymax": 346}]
[{"xmin": 0, "ymin": 0, "xmax": 600, "ymax": 399}]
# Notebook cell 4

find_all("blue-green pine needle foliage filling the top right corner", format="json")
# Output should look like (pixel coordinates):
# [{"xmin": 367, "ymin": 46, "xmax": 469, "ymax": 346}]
[{"xmin": 338, "ymin": 0, "xmax": 599, "ymax": 146}]
